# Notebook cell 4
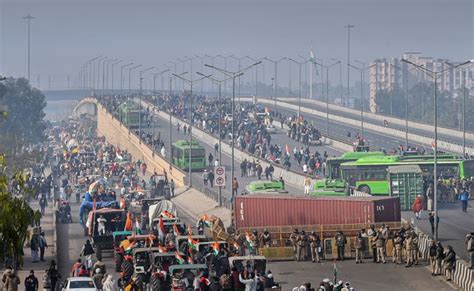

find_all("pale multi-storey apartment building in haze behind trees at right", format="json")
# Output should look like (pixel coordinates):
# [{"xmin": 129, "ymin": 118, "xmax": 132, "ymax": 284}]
[{"xmin": 369, "ymin": 52, "xmax": 474, "ymax": 113}]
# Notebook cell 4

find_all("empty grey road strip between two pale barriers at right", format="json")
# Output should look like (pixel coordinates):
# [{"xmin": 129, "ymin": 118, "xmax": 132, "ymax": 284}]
[{"xmin": 284, "ymin": 99, "xmax": 474, "ymax": 146}]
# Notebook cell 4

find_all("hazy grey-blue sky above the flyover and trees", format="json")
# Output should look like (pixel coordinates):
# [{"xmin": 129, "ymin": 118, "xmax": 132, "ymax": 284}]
[{"xmin": 0, "ymin": 0, "xmax": 474, "ymax": 89}]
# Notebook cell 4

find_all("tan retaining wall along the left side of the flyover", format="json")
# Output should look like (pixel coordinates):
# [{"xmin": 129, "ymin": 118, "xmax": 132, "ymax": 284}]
[{"xmin": 97, "ymin": 104, "xmax": 186, "ymax": 187}]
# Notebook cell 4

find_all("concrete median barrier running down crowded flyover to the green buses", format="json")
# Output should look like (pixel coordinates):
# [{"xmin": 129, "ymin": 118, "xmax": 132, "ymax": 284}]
[{"xmin": 141, "ymin": 101, "xmax": 305, "ymax": 193}]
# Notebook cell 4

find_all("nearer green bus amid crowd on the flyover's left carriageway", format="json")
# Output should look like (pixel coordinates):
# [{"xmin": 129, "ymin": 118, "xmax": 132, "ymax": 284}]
[{"xmin": 171, "ymin": 140, "xmax": 206, "ymax": 170}]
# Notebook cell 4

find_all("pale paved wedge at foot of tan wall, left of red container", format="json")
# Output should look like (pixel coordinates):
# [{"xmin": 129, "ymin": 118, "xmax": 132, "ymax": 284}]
[{"xmin": 171, "ymin": 188, "xmax": 232, "ymax": 227}]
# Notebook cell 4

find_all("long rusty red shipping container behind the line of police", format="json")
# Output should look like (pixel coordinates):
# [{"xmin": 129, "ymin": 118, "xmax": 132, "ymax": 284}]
[{"xmin": 234, "ymin": 195, "xmax": 401, "ymax": 229}]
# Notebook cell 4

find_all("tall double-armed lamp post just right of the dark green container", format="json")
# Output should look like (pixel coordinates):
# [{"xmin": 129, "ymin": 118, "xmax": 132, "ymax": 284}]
[{"xmin": 402, "ymin": 59, "xmax": 472, "ymax": 240}]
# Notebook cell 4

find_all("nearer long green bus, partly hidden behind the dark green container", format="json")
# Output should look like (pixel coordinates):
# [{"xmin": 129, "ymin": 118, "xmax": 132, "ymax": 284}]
[{"xmin": 341, "ymin": 155, "xmax": 474, "ymax": 195}]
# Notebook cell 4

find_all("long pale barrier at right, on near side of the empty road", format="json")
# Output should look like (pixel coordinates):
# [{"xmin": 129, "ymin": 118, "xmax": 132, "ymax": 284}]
[{"xmin": 259, "ymin": 99, "xmax": 474, "ymax": 154}]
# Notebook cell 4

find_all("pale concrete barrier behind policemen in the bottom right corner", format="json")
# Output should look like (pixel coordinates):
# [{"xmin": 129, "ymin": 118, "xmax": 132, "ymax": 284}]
[{"xmin": 418, "ymin": 232, "xmax": 474, "ymax": 291}]
